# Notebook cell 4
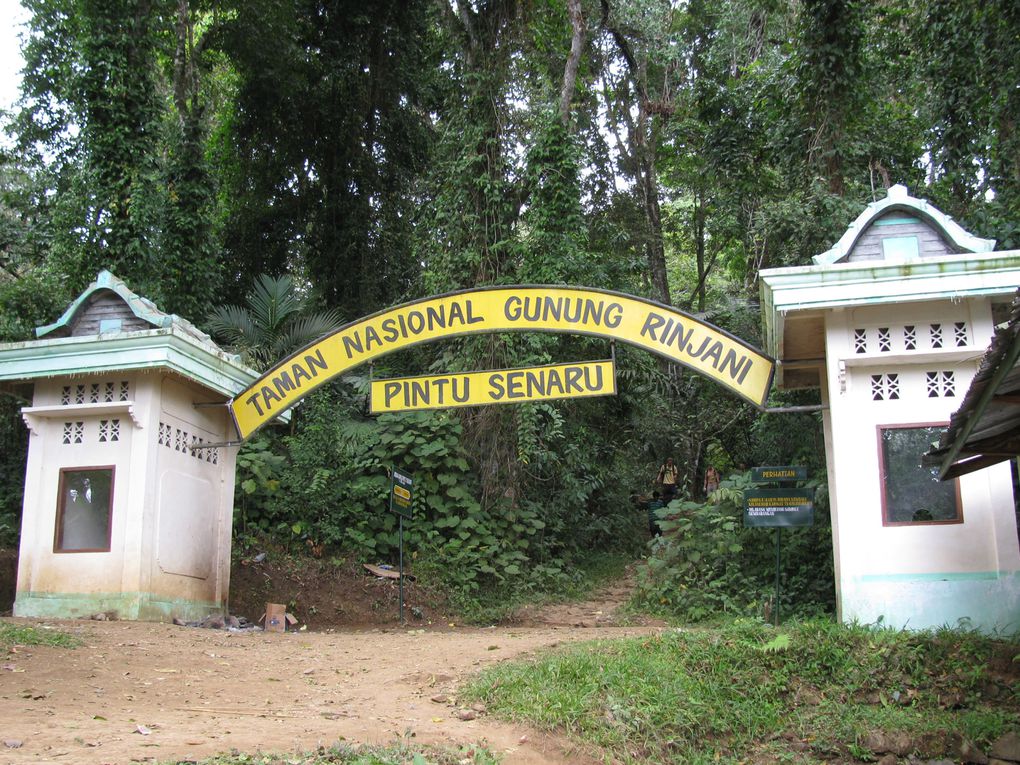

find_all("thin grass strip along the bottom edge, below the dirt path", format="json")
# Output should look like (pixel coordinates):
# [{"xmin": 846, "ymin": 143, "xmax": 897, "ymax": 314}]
[{"xmin": 158, "ymin": 742, "xmax": 499, "ymax": 765}]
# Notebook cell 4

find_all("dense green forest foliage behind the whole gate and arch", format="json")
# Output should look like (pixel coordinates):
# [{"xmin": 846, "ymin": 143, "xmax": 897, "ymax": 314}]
[{"xmin": 0, "ymin": 0, "xmax": 1020, "ymax": 615}]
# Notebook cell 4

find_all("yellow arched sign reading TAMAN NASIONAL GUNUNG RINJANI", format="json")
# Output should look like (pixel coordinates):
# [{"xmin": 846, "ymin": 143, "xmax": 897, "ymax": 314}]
[{"xmin": 230, "ymin": 286, "xmax": 773, "ymax": 439}]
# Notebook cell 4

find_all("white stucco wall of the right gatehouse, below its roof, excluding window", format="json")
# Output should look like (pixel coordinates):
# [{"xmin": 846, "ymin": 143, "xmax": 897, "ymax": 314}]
[{"xmin": 825, "ymin": 298, "xmax": 1020, "ymax": 631}]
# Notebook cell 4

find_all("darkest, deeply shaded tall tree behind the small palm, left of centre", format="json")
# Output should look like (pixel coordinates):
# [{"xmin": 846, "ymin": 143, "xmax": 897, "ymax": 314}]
[{"xmin": 215, "ymin": 0, "xmax": 439, "ymax": 315}]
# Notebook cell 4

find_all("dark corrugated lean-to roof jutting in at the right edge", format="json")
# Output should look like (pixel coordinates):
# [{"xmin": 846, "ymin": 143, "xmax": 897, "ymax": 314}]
[{"xmin": 925, "ymin": 290, "xmax": 1020, "ymax": 480}]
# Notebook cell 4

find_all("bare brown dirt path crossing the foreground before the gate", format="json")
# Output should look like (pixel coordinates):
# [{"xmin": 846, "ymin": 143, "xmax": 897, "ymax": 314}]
[{"xmin": 0, "ymin": 588, "xmax": 660, "ymax": 765}]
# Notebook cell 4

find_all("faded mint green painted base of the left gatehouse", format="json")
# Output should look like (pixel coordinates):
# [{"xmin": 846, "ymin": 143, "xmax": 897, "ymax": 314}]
[{"xmin": 14, "ymin": 593, "xmax": 226, "ymax": 621}]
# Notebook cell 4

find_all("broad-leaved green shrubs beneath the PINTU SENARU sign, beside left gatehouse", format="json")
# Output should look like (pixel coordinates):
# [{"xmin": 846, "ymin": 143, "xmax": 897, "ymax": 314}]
[{"xmin": 230, "ymin": 378, "xmax": 643, "ymax": 620}]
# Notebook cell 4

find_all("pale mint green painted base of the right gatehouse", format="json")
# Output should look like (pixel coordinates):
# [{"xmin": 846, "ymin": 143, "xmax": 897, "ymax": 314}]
[{"xmin": 840, "ymin": 571, "xmax": 1020, "ymax": 635}]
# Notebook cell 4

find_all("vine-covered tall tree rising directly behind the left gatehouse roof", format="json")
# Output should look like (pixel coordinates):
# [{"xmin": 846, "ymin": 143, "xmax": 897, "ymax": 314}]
[{"xmin": 15, "ymin": 0, "xmax": 224, "ymax": 318}]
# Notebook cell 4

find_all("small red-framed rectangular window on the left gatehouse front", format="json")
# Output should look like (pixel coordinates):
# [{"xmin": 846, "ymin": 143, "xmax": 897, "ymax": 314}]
[{"xmin": 53, "ymin": 466, "xmax": 113, "ymax": 553}]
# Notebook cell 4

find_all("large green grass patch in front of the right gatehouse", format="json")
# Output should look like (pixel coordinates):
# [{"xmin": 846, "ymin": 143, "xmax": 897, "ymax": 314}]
[{"xmin": 463, "ymin": 622, "xmax": 1020, "ymax": 763}]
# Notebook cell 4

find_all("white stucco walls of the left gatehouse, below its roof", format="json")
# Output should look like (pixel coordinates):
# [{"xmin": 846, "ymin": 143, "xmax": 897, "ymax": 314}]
[{"xmin": 14, "ymin": 369, "xmax": 237, "ymax": 619}]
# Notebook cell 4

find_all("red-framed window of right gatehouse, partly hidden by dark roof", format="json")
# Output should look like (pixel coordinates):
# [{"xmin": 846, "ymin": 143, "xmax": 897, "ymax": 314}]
[{"xmin": 878, "ymin": 424, "xmax": 963, "ymax": 525}]
